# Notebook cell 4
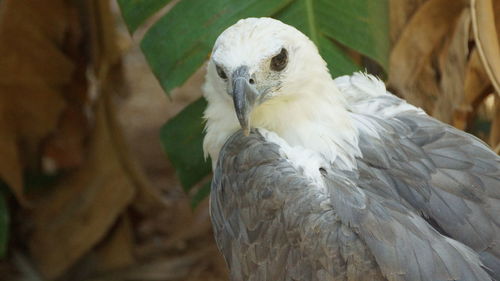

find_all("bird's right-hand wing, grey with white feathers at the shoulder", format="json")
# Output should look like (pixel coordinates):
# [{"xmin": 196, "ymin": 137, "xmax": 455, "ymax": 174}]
[{"xmin": 336, "ymin": 74, "xmax": 500, "ymax": 280}]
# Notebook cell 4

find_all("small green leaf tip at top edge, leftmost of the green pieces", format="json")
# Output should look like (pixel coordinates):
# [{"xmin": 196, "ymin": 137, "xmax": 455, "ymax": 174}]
[{"xmin": 118, "ymin": 0, "xmax": 172, "ymax": 33}]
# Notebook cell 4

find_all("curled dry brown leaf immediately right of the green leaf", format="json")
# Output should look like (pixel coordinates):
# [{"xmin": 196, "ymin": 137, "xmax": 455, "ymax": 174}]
[{"xmin": 389, "ymin": 0, "xmax": 465, "ymax": 110}]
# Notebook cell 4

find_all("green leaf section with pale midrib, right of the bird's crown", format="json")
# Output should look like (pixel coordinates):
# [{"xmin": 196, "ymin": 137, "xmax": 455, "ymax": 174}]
[{"xmin": 273, "ymin": 0, "xmax": 389, "ymax": 76}]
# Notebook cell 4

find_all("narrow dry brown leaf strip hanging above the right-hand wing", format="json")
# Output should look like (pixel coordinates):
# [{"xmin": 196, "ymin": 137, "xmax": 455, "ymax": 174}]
[{"xmin": 432, "ymin": 8, "xmax": 470, "ymax": 123}]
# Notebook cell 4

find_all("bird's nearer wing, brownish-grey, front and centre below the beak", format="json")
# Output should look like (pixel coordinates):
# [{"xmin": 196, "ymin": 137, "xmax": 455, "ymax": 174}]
[{"xmin": 211, "ymin": 129, "xmax": 491, "ymax": 281}]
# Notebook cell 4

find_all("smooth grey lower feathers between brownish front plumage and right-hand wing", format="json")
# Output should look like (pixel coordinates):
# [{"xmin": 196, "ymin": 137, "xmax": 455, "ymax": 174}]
[{"xmin": 327, "ymin": 170, "xmax": 491, "ymax": 281}]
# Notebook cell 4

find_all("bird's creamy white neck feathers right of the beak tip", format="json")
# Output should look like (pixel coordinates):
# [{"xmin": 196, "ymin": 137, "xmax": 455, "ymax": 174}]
[{"xmin": 251, "ymin": 77, "xmax": 360, "ymax": 170}]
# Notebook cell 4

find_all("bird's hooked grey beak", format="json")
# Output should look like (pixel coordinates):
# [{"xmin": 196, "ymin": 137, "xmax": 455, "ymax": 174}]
[{"xmin": 232, "ymin": 66, "xmax": 258, "ymax": 136}]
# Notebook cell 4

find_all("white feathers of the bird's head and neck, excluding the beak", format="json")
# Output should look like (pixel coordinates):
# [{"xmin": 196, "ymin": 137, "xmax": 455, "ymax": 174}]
[{"xmin": 203, "ymin": 18, "xmax": 357, "ymax": 170}]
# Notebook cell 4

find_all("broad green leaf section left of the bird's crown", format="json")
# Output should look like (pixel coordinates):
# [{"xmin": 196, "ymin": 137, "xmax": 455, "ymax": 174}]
[{"xmin": 141, "ymin": 0, "xmax": 290, "ymax": 92}]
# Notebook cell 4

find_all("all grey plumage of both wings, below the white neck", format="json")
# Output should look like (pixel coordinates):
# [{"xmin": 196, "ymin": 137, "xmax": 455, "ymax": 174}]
[{"xmin": 210, "ymin": 75, "xmax": 500, "ymax": 281}]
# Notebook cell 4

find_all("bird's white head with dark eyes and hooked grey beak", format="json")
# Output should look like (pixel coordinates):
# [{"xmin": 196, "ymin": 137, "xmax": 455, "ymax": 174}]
[{"xmin": 206, "ymin": 18, "xmax": 331, "ymax": 134}]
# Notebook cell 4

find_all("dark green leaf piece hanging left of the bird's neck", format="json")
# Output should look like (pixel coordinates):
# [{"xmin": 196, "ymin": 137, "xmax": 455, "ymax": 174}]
[{"xmin": 160, "ymin": 98, "xmax": 211, "ymax": 191}]
